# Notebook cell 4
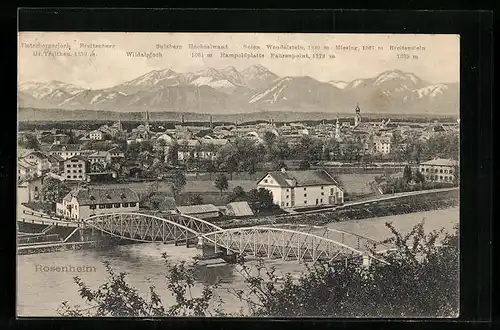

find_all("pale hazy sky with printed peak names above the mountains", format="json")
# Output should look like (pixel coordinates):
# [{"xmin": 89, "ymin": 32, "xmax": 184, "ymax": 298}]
[{"xmin": 18, "ymin": 32, "xmax": 460, "ymax": 89}]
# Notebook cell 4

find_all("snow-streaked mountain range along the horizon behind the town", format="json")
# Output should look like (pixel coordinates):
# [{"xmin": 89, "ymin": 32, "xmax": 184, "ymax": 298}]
[{"xmin": 18, "ymin": 65, "xmax": 459, "ymax": 115}]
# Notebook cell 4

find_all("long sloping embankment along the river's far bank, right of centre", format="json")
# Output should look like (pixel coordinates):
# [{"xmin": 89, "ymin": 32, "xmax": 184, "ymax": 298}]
[{"xmin": 217, "ymin": 190, "xmax": 460, "ymax": 228}]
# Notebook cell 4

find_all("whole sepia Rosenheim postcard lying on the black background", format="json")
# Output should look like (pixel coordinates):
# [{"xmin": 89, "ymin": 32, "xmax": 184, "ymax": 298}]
[{"xmin": 16, "ymin": 32, "xmax": 465, "ymax": 318}]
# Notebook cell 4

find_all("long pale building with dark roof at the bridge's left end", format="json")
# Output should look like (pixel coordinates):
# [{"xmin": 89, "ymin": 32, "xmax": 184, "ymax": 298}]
[{"xmin": 56, "ymin": 187, "xmax": 139, "ymax": 220}]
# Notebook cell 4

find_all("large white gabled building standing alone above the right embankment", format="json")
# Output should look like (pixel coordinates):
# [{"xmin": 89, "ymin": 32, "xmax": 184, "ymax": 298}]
[{"xmin": 257, "ymin": 170, "xmax": 344, "ymax": 208}]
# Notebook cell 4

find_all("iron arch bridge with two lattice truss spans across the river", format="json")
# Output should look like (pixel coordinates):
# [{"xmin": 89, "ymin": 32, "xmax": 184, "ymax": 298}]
[{"xmin": 83, "ymin": 212, "xmax": 383, "ymax": 262}]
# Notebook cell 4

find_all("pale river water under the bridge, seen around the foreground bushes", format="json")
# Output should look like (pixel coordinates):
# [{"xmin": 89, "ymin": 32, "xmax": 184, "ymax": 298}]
[{"xmin": 17, "ymin": 208, "xmax": 459, "ymax": 316}]
